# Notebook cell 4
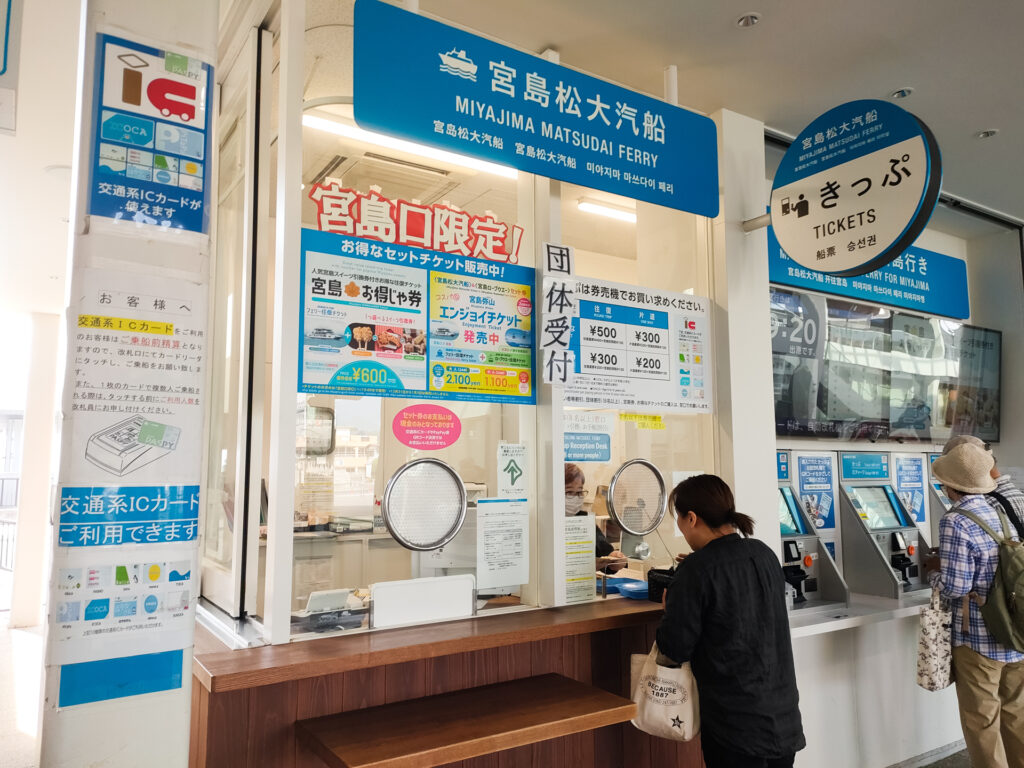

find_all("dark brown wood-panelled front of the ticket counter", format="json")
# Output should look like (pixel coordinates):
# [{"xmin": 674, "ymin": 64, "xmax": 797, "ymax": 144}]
[{"xmin": 189, "ymin": 624, "xmax": 703, "ymax": 768}]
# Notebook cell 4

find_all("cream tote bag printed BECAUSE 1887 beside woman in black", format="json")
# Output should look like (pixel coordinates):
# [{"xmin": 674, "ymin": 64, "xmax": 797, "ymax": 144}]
[{"xmin": 630, "ymin": 643, "xmax": 700, "ymax": 741}]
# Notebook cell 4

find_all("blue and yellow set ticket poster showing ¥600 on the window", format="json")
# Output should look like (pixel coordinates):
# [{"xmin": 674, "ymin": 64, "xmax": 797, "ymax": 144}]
[{"xmin": 299, "ymin": 229, "xmax": 537, "ymax": 403}]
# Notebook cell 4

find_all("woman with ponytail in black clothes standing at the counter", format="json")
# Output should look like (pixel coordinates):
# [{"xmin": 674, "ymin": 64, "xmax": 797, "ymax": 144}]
[{"xmin": 657, "ymin": 475, "xmax": 805, "ymax": 768}]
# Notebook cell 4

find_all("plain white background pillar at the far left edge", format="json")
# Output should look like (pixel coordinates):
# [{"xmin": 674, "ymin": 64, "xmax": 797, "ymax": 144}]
[{"xmin": 10, "ymin": 312, "xmax": 60, "ymax": 627}]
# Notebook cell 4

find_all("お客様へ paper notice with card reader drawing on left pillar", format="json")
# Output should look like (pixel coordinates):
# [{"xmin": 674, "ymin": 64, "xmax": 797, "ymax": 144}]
[{"xmin": 61, "ymin": 269, "xmax": 207, "ymax": 485}]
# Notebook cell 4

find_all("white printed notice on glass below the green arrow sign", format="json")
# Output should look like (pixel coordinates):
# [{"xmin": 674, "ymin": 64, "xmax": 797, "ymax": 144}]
[{"xmin": 476, "ymin": 499, "xmax": 529, "ymax": 590}]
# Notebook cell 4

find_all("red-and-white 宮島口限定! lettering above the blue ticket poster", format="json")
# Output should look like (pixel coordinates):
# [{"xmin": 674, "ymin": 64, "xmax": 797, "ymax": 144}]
[{"xmin": 309, "ymin": 182, "xmax": 522, "ymax": 264}]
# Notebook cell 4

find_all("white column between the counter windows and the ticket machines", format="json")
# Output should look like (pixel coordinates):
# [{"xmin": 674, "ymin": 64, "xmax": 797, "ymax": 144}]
[{"xmin": 712, "ymin": 110, "xmax": 781, "ymax": 551}]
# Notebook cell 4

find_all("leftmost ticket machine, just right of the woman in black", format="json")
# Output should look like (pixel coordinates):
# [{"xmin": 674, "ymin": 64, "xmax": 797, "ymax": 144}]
[{"xmin": 776, "ymin": 451, "xmax": 849, "ymax": 610}]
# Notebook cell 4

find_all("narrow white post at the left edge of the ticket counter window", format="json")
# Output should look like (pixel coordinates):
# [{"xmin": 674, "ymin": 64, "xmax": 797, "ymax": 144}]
[{"xmin": 264, "ymin": 2, "xmax": 305, "ymax": 644}]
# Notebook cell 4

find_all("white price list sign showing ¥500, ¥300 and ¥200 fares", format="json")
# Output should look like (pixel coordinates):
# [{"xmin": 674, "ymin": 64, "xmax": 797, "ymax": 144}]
[{"xmin": 565, "ymin": 281, "xmax": 712, "ymax": 413}]
